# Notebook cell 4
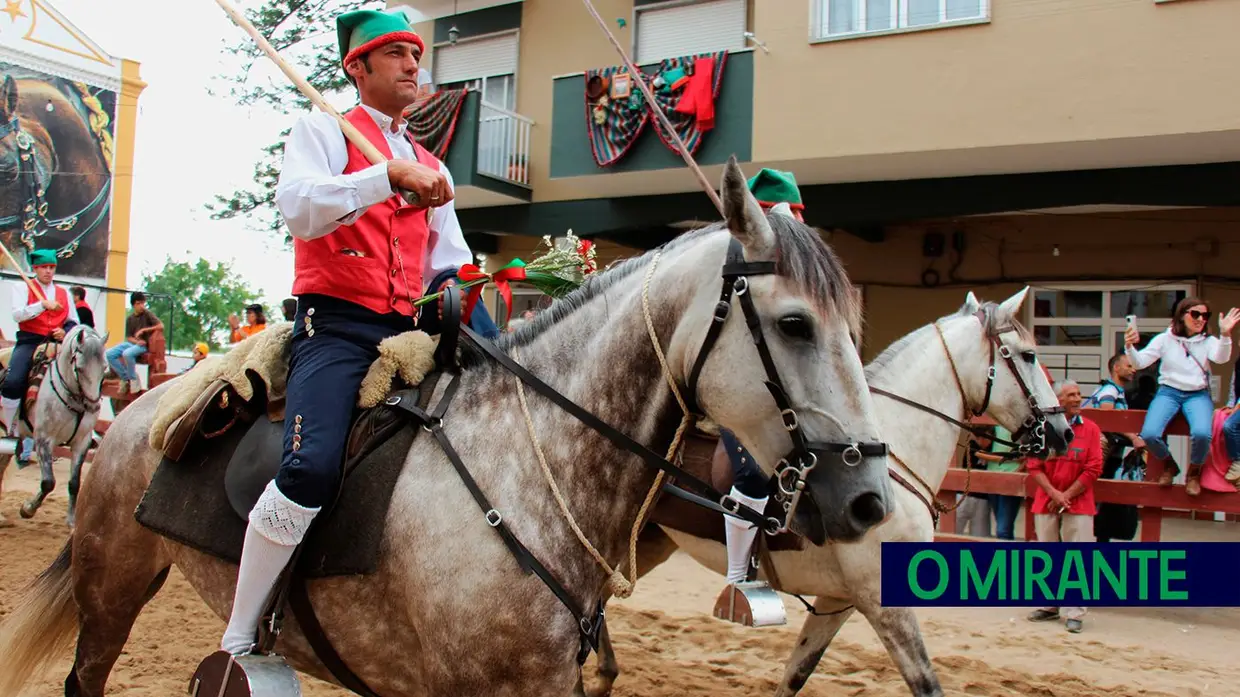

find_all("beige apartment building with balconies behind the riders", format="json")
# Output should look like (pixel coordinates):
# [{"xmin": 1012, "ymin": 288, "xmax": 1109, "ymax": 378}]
[{"xmin": 392, "ymin": 0, "xmax": 1240, "ymax": 402}]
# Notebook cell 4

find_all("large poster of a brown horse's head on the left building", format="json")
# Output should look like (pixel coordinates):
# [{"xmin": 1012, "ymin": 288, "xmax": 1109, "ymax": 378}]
[{"xmin": 0, "ymin": 61, "xmax": 117, "ymax": 279}]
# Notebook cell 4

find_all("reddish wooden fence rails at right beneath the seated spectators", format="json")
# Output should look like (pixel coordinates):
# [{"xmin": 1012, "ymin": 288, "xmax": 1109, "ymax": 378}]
[{"xmin": 935, "ymin": 409, "xmax": 1240, "ymax": 542}]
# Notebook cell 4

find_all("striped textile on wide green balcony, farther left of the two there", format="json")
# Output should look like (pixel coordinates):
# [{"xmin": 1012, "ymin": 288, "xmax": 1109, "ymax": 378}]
[{"xmin": 585, "ymin": 66, "xmax": 650, "ymax": 167}]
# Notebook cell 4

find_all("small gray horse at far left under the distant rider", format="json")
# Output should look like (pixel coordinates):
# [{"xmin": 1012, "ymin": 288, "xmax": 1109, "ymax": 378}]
[{"xmin": 0, "ymin": 325, "xmax": 108, "ymax": 527}]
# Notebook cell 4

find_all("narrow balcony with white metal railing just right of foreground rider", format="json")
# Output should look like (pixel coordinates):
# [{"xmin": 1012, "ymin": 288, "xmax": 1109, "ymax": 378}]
[{"xmin": 445, "ymin": 91, "xmax": 534, "ymax": 208}]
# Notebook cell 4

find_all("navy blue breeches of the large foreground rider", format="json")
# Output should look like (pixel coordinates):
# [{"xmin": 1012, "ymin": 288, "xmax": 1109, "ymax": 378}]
[{"xmin": 275, "ymin": 290, "xmax": 494, "ymax": 508}]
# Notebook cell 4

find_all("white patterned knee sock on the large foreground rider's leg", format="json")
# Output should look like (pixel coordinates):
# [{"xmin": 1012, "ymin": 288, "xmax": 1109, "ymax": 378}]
[{"xmin": 219, "ymin": 481, "xmax": 319, "ymax": 655}]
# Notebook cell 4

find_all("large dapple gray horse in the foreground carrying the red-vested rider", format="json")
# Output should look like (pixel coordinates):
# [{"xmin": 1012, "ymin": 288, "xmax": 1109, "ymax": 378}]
[{"xmin": 0, "ymin": 160, "xmax": 893, "ymax": 697}]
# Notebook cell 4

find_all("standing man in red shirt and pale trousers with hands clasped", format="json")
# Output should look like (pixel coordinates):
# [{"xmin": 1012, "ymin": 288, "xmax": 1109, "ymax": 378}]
[{"xmin": 1025, "ymin": 380, "xmax": 1102, "ymax": 634}]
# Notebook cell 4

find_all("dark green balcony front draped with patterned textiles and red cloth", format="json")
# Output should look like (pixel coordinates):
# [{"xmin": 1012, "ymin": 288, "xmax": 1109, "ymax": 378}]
[{"xmin": 551, "ymin": 50, "xmax": 754, "ymax": 184}]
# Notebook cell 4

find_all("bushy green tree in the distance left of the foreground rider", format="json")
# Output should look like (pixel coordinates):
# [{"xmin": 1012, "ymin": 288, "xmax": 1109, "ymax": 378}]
[{"xmin": 143, "ymin": 258, "xmax": 263, "ymax": 350}]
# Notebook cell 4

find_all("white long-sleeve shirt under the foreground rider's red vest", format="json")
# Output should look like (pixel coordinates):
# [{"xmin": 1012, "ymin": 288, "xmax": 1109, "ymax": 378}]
[{"xmin": 275, "ymin": 104, "xmax": 474, "ymax": 283}]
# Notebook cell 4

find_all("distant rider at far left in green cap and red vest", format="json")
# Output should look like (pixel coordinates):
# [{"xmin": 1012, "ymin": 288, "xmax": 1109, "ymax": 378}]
[{"xmin": 0, "ymin": 249, "xmax": 78, "ymax": 437}]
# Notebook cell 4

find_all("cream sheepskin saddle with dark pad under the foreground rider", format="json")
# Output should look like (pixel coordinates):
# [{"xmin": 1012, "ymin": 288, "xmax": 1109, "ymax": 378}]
[{"xmin": 134, "ymin": 324, "xmax": 440, "ymax": 578}]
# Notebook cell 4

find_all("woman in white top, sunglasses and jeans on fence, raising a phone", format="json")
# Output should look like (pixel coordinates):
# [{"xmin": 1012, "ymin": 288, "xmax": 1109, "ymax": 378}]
[{"xmin": 1123, "ymin": 298, "xmax": 1240, "ymax": 496}]
